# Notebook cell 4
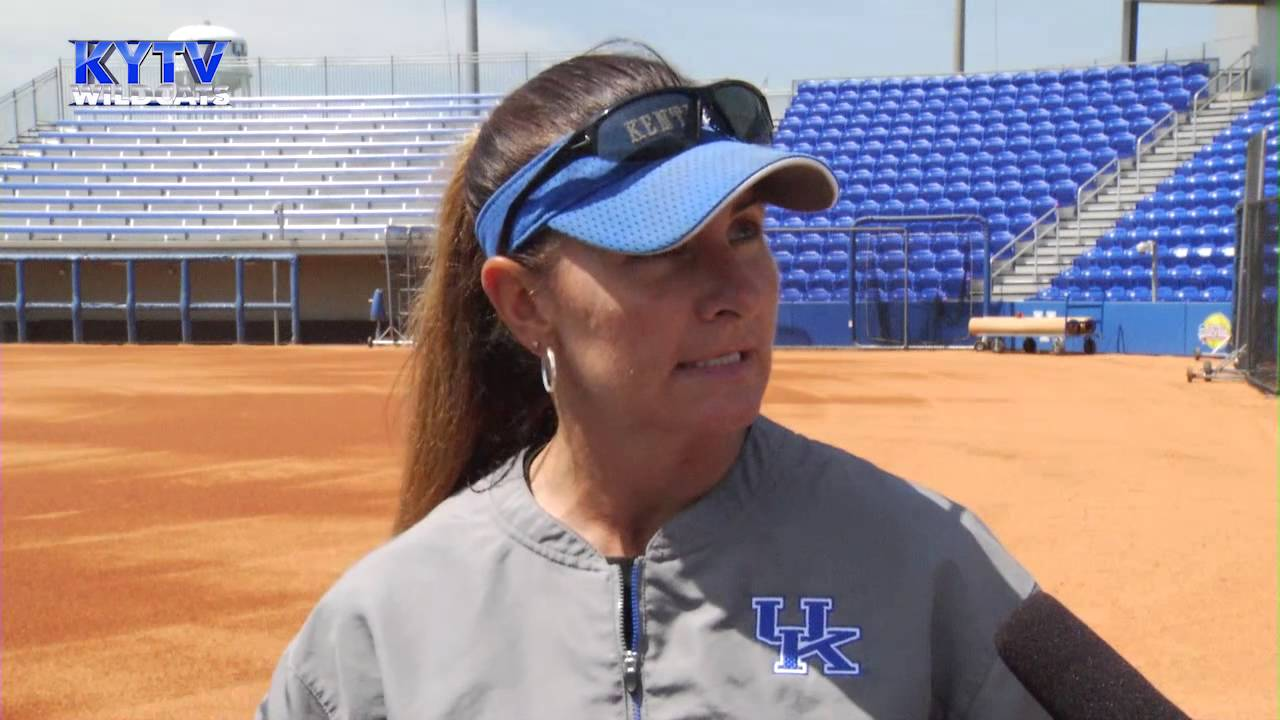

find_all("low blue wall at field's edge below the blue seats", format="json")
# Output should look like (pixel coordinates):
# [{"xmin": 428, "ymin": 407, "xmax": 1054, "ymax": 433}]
[{"xmin": 774, "ymin": 301, "xmax": 1231, "ymax": 355}]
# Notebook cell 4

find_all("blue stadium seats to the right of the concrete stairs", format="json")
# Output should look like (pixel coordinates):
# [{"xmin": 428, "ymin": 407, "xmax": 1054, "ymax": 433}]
[{"xmin": 1037, "ymin": 86, "xmax": 1280, "ymax": 302}]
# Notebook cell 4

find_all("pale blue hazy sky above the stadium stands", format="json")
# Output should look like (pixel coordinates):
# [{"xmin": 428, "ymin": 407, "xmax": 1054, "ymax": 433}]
[{"xmin": 0, "ymin": 0, "xmax": 1256, "ymax": 92}]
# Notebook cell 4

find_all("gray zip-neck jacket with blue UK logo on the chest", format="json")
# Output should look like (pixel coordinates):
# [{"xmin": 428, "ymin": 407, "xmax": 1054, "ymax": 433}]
[{"xmin": 257, "ymin": 418, "xmax": 1047, "ymax": 720}]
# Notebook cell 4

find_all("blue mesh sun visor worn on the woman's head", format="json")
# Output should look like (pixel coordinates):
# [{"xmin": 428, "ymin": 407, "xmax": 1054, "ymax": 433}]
[{"xmin": 476, "ymin": 131, "xmax": 840, "ymax": 258}]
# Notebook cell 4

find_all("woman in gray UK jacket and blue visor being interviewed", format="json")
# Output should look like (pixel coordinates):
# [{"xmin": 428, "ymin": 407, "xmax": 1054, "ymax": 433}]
[{"xmin": 259, "ymin": 47, "xmax": 1043, "ymax": 720}]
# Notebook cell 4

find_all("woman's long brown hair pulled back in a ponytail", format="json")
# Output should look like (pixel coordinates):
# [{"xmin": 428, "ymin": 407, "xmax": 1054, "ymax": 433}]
[{"xmin": 394, "ymin": 46, "xmax": 687, "ymax": 533}]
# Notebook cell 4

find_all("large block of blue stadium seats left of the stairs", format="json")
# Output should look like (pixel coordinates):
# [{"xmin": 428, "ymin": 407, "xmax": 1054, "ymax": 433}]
[{"xmin": 765, "ymin": 61, "xmax": 1212, "ymax": 301}]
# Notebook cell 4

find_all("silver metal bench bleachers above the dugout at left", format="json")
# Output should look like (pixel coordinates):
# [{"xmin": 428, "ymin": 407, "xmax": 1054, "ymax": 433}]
[{"xmin": 0, "ymin": 95, "xmax": 498, "ymax": 244}]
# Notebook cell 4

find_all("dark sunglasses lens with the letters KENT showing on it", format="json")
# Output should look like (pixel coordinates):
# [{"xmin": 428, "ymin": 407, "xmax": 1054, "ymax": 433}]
[{"xmin": 596, "ymin": 92, "xmax": 698, "ymax": 161}]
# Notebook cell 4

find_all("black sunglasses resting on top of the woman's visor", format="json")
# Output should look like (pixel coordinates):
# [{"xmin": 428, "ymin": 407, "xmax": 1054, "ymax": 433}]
[{"xmin": 498, "ymin": 79, "xmax": 773, "ymax": 254}]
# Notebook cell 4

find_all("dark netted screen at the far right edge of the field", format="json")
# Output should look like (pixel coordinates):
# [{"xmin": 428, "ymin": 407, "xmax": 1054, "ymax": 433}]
[{"xmin": 1235, "ymin": 197, "xmax": 1280, "ymax": 393}]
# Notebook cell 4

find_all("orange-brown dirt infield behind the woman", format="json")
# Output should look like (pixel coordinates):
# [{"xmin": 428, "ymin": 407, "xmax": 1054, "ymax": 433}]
[{"xmin": 0, "ymin": 346, "xmax": 1277, "ymax": 720}]
